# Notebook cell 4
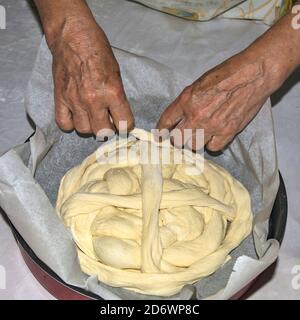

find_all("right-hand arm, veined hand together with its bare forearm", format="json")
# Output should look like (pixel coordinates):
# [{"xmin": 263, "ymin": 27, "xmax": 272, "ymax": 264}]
[{"xmin": 157, "ymin": 5, "xmax": 300, "ymax": 151}]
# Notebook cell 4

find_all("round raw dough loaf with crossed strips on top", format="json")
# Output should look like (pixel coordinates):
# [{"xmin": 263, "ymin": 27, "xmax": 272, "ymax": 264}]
[{"xmin": 57, "ymin": 129, "xmax": 252, "ymax": 296}]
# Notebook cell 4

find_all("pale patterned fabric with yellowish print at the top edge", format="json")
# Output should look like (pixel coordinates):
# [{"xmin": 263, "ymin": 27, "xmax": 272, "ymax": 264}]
[{"xmin": 131, "ymin": 0, "xmax": 293, "ymax": 24}]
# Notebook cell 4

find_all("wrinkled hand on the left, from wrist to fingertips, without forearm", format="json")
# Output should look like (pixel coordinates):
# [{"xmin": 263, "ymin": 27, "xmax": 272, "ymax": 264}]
[{"xmin": 50, "ymin": 20, "xmax": 134, "ymax": 136}]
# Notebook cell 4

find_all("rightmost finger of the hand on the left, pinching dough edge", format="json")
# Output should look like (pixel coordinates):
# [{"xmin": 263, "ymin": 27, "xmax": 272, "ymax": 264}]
[{"xmin": 109, "ymin": 98, "xmax": 134, "ymax": 133}]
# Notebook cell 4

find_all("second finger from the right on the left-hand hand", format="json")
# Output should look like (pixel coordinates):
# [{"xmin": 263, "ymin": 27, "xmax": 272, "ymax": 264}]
[{"xmin": 90, "ymin": 108, "xmax": 116, "ymax": 141}]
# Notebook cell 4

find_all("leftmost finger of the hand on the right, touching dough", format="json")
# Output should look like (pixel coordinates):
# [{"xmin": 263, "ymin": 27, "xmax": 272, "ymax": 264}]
[{"xmin": 156, "ymin": 95, "xmax": 184, "ymax": 130}]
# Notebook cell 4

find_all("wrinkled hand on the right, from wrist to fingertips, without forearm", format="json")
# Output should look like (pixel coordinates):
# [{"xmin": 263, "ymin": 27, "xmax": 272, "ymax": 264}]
[{"xmin": 157, "ymin": 53, "xmax": 282, "ymax": 151}]
